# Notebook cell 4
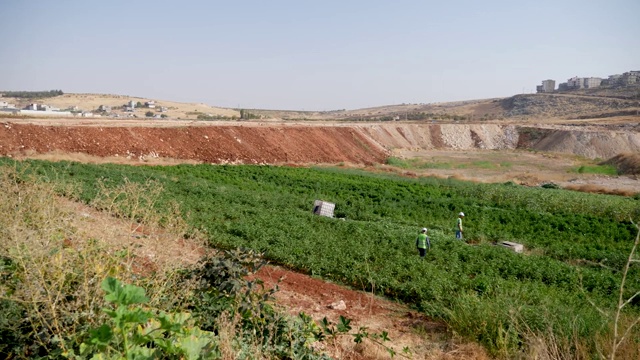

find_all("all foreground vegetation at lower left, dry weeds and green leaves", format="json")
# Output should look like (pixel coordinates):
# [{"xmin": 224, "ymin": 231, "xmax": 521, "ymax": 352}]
[{"xmin": 0, "ymin": 167, "xmax": 395, "ymax": 360}]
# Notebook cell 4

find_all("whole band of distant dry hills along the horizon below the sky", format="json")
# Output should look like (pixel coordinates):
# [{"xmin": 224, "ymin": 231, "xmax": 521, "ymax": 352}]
[{"xmin": 3, "ymin": 84, "xmax": 640, "ymax": 122}]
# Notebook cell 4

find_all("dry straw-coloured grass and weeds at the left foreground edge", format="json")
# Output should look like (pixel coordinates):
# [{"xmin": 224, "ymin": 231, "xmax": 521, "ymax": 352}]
[{"xmin": 0, "ymin": 167, "xmax": 201, "ymax": 350}]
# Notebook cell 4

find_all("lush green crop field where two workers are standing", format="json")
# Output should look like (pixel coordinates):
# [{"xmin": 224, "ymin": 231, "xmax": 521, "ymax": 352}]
[{"xmin": 6, "ymin": 159, "xmax": 640, "ymax": 357}]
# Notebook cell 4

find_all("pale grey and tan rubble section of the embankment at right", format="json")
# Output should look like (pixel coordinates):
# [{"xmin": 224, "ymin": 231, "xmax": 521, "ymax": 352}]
[{"xmin": 357, "ymin": 124, "xmax": 640, "ymax": 159}]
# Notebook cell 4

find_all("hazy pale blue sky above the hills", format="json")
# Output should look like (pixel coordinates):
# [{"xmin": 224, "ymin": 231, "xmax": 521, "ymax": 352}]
[{"xmin": 0, "ymin": 0, "xmax": 640, "ymax": 110}]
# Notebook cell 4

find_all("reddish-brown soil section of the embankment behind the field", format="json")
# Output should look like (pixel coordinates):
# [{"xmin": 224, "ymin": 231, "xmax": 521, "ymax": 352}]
[{"xmin": 0, "ymin": 122, "xmax": 386, "ymax": 164}]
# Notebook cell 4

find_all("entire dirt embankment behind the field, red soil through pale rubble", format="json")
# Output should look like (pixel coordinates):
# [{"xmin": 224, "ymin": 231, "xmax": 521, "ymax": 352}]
[{"xmin": 0, "ymin": 120, "xmax": 640, "ymax": 164}]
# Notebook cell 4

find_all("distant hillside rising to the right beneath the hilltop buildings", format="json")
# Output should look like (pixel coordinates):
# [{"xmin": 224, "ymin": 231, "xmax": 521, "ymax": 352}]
[{"xmin": 250, "ymin": 85, "xmax": 640, "ymax": 122}]
